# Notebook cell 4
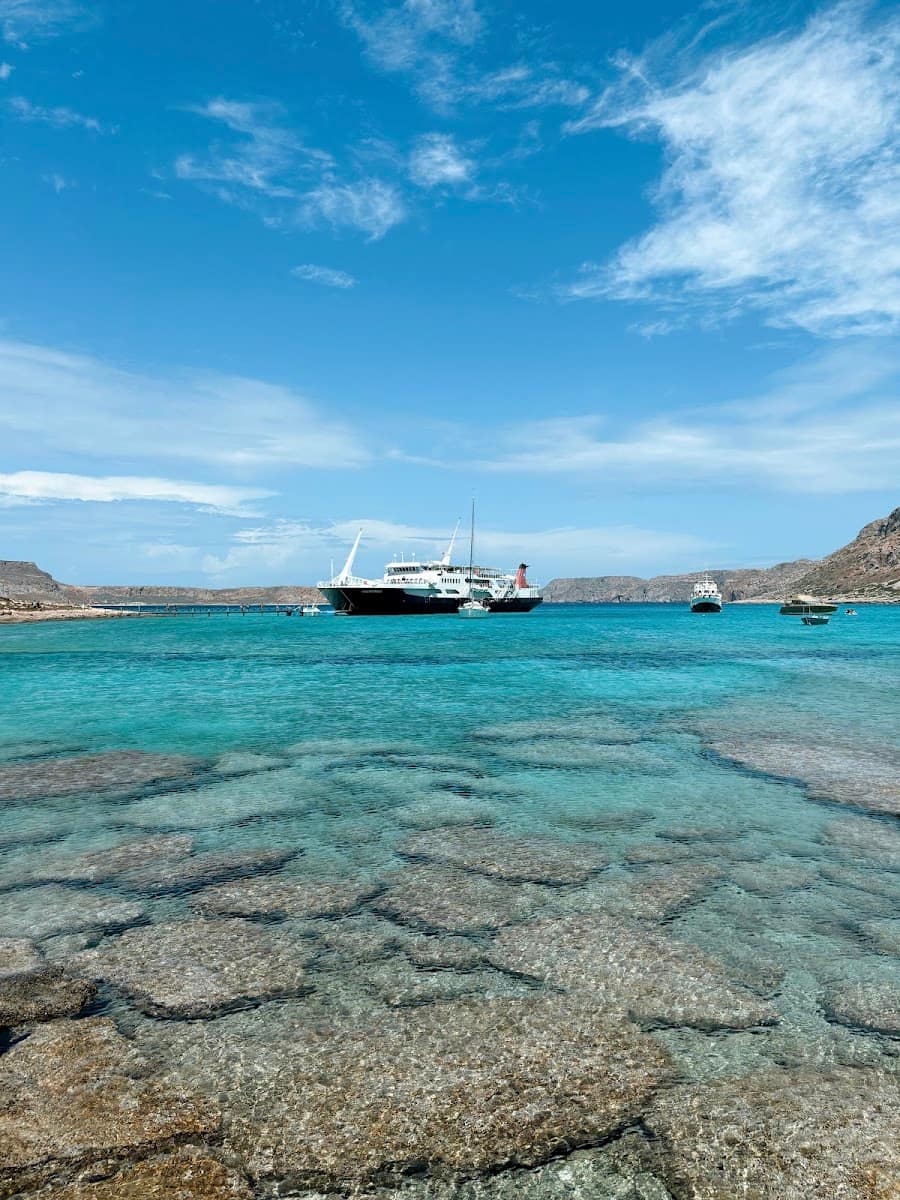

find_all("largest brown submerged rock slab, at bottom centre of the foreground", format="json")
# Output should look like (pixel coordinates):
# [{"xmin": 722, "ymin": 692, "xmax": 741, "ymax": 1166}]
[{"xmin": 164, "ymin": 997, "xmax": 667, "ymax": 1192}]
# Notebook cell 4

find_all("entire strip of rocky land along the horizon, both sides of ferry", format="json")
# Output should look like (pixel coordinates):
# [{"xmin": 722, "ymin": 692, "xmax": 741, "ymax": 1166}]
[{"xmin": 0, "ymin": 508, "xmax": 900, "ymax": 618}]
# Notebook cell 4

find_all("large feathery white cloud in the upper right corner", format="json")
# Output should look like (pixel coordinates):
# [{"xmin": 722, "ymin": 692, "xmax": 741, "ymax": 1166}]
[{"xmin": 563, "ymin": 4, "xmax": 900, "ymax": 335}]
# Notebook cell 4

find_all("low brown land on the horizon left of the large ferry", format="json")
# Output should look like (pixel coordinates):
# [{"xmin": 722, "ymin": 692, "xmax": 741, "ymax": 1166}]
[{"xmin": 0, "ymin": 559, "xmax": 324, "ymax": 607}]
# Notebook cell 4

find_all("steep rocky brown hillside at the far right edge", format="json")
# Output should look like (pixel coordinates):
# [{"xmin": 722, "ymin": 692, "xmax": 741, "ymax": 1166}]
[{"xmin": 797, "ymin": 508, "xmax": 900, "ymax": 600}]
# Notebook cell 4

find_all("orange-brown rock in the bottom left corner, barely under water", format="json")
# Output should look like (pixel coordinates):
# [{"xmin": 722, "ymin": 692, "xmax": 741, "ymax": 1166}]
[{"xmin": 0, "ymin": 1018, "xmax": 220, "ymax": 1196}]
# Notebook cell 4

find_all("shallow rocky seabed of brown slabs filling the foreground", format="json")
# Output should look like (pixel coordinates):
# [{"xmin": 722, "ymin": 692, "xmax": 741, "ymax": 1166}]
[{"xmin": 0, "ymin": 710, "xmax": 900, "ymax": 1200}]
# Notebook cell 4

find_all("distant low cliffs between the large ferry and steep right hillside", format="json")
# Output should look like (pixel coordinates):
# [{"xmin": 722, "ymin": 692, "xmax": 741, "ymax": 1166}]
[{"xmin": 544, "ymin": 558, "xmax": 815, "ymax": 604}]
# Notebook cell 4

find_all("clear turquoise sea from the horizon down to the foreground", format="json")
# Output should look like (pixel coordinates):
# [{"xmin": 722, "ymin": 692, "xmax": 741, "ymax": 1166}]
[{"xmin": 0, "ymin": 605, "xmax": 900, "ymax": 1200}]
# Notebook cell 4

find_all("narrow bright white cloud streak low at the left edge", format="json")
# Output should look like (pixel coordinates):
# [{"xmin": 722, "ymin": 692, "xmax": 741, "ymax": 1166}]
[{"xmin": 0, "ymin": 470, "xmax": 271, "ymax": 516}]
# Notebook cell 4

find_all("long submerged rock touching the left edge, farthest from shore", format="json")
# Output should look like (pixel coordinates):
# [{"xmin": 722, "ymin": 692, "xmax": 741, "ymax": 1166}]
[{"xmin": 0, "ymin": 750, "xmax": 199, "ymax": 800}]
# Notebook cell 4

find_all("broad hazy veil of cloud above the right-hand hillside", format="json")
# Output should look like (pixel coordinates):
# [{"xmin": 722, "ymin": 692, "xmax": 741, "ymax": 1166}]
[{"xmin": 472, "ymin": 343, "xmax": 900, "ymax": 493}]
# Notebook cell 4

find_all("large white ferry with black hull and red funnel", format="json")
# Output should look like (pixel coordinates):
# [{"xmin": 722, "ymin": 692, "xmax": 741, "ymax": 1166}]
[{"xmin": 318, "ymin": 526, "xmax": 542, "ymax": 617}]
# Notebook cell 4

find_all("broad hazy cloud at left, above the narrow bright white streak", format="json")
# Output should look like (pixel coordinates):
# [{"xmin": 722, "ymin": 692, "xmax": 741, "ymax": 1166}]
[{"xmin": 0, "ymin": 338, "xmax": 370, "ymax": 470}]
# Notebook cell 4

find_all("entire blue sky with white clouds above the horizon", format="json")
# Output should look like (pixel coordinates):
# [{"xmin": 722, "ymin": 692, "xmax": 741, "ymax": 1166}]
[{"xmin": 0, "ymin": 0, "xmax": 900, "ymax": 587}]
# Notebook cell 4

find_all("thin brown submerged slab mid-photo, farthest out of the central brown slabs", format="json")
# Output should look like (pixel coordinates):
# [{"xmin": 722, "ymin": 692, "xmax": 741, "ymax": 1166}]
[{"xmin": 400, "ymin": 829, "xmax": 610, "ymax": 883}]
